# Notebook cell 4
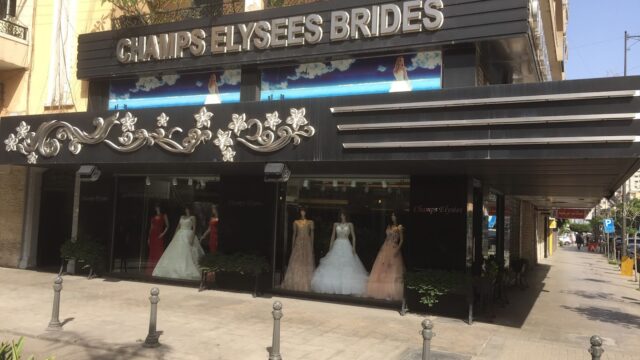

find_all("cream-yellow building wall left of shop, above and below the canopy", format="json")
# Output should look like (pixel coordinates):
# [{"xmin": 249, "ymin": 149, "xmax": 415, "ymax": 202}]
[{"xmin": 0, "ymin": 0, "xmax": 111, "ymax": 267}]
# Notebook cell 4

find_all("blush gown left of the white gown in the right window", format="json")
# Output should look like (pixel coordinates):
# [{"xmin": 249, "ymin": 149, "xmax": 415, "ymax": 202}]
[{"xmin": 282, "ymin": 220, "xmax": 315, "ymax": 291}]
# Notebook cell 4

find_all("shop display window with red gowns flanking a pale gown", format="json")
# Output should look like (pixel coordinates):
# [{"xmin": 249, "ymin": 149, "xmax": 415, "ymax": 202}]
[{"xmin": 111, "ymin": 176, "xmax": 220, "ymax": 280}]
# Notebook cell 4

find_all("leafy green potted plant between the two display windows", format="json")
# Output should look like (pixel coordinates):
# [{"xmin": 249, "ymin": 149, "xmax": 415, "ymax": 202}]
[{"xmin": 200, "ymin": 253, "xmax": 269, "ymax": 297}]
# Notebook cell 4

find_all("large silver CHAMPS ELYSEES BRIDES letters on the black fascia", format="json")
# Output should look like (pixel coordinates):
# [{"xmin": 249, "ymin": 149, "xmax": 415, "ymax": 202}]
[{"xmin": 116, "ymin": 0, "xmax": 444, "ymax": 63}]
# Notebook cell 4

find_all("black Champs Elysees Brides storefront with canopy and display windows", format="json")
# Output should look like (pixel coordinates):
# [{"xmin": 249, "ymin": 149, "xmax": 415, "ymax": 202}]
[{"xmin": 0, "ymin": 0, "xmax": 640, "ymax": 312}]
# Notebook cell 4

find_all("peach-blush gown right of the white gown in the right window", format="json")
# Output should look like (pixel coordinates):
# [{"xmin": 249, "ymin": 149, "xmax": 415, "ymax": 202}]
[{"xmin": 367, "ymin": 226, "xmax": 404, "ymax": 300}]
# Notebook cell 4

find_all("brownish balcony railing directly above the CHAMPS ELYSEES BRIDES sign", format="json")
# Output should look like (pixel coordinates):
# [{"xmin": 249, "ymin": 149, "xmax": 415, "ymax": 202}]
[{"xmin": 111, "ymin": 0, "xmax": 319, "ymax": 29}]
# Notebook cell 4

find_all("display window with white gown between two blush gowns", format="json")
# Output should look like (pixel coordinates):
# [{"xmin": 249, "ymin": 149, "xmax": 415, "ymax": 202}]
[{"xmin": 275, "ymin": 177, "xmax": 410, "ymax": 300}]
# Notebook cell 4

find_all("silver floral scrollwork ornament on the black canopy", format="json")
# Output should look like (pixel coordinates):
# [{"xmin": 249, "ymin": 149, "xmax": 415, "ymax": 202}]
[{"xmin": 4, "ymin": 107, "xmax": 315, "ymax": 164}]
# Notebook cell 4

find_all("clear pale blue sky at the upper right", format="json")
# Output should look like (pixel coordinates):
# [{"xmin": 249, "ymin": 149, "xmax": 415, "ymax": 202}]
[{"xmin": 566, "ymin": 0, "xmax": 640, "ymax": 80}]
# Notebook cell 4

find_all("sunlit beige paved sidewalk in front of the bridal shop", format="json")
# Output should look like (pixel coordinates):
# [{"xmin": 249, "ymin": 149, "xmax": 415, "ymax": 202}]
[{"xmin": 0, "ymin": 248, "xmax": 640, "ymax": 360}]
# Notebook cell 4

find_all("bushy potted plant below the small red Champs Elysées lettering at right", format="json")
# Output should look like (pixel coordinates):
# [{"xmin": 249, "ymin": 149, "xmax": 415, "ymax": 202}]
[{"xmin": 405, "ymin": 269, "xmax": 465, "ymax": 310}]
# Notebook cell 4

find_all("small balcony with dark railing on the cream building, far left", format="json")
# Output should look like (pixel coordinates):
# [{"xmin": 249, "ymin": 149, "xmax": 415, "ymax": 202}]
[{"xmin": 0, "ymin": 19, "xmax": 29, "ymax": 70}]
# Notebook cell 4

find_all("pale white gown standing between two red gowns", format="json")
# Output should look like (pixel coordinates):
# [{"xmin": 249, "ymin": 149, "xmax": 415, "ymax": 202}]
[{"xmin": 153, "ymin": 216, "xmax": 204, "ymax": 280}]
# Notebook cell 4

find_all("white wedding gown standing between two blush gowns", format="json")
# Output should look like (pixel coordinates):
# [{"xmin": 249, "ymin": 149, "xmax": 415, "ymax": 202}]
[{"xmin": 311, "ymin": 223, "xmax": 369, "ymax": 295}]
